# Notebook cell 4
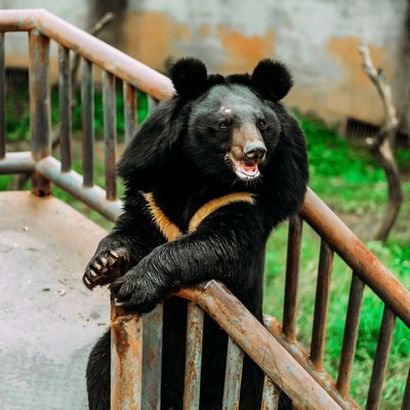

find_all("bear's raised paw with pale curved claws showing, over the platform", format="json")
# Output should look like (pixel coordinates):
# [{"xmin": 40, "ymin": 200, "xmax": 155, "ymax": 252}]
[{"xmin": 83, "ymin": 247, "xmax": 131, "ymax": 289}]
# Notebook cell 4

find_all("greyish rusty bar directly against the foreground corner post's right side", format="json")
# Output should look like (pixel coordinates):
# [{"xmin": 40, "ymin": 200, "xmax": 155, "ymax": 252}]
[{"xmin": 141, "ymin": 304, "xmax": 163, "ymax": 410}]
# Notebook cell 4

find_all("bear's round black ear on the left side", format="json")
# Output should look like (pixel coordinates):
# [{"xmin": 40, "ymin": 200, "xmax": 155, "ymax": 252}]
[{"xmin": 171, "ymin": 57, "xmax": 208, "ymax": 99}]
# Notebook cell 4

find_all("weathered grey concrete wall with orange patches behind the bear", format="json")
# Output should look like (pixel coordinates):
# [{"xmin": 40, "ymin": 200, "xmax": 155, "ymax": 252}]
[{"xmin": 0, "ymin": 0, "xmax": 407, "ymax": 123}]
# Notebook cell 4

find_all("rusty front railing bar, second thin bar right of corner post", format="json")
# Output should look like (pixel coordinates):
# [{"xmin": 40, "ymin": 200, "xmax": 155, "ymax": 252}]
[{"xmin": 183, "ymin": 302, "xmax": 204, "ymax": 410}]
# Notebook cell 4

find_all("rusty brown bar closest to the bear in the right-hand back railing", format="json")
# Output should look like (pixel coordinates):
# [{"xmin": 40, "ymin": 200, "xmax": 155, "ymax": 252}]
[{"xmin": 283, "ymin": 215, "xmax": 303, "ymax": 340}]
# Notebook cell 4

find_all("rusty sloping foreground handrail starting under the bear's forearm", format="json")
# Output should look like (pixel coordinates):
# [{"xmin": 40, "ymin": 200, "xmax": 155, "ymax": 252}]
[{"xmin": 178, "ymin": 280, "xmax": 341, "ymax": 410}]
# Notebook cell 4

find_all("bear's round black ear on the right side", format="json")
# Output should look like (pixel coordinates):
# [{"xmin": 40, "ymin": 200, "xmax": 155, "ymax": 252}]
[{"xmin": 252, "ymin": 59, "xmax": 293, "ymax": 101}]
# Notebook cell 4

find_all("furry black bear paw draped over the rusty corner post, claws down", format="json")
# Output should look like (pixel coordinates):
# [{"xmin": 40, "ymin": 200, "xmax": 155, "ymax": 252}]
[{"xmin": 110, "ymin": 263, "xmax": 179, "ymax": 313}]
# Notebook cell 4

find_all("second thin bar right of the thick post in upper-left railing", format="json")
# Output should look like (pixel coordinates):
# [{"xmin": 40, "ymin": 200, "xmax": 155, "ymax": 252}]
[{"xmin": 81, "ymin": 58, "xmax": 94, "ymax": 187}]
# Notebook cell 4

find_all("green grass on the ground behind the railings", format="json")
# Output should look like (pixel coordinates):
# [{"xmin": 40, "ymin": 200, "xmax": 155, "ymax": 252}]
[{"xmin": 0, "ymin": 92, "xmax": 410, "ymax": 410}]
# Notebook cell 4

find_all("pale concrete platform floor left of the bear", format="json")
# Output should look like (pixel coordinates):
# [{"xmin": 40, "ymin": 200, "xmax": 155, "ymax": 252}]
[{"xmin": 0, "ymin": 192, "xmax": 109, "ymax": 410}]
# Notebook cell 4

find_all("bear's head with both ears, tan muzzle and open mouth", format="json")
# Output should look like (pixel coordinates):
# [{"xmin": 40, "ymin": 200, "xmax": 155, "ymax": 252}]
[{"xmin": 171, "ymin": 59, "xmax": 292, "ymax": 182}]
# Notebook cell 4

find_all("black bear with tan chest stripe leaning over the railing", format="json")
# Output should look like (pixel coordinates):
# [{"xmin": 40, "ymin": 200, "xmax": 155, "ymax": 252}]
[{"xmin": 83, "ymin": 58, "xmax": 308, "ymax": 409}]
